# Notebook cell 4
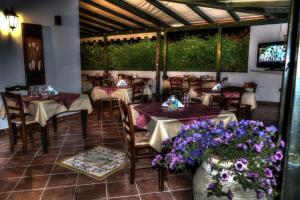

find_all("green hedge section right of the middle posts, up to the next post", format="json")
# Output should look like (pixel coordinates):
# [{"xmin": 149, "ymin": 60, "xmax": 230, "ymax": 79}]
[{"xmin": 168, "ymin": 36, "xmax": 217, "ymax": 71}]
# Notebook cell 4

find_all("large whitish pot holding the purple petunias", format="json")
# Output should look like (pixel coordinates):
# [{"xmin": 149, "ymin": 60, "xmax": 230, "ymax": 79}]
[{"xmin": 193, "ymin": 159, "xmax": 264, "ymax": 200}]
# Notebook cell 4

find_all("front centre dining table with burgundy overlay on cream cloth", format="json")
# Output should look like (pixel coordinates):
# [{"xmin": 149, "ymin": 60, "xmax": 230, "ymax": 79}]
[{"xmin": 130, "ymin": 103, "xmax": 237, "ymax": 152}]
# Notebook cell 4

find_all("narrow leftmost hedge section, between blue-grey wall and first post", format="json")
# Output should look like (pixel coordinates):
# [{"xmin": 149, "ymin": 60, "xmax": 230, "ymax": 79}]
[{"xmin": 80, "ymin": 43, "xmax": 105, "ymax": 70}]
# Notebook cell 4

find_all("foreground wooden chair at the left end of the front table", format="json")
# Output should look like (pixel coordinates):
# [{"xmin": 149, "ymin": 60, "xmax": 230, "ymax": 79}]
[{"xmin": 119, "ymin": 101, "xmax": 154, "ymax": 183}]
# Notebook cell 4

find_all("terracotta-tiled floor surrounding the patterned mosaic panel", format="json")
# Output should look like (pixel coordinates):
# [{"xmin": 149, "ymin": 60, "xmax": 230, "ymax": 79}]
[{"xmin": 0, "ymin": 114, "xmax": 192, "ymax": 200}]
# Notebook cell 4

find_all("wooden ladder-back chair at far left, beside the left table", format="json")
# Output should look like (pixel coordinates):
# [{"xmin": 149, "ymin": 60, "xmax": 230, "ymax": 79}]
[{"xmin": 1, "ymin": 92, "xmax": 48, "ymax": 153}]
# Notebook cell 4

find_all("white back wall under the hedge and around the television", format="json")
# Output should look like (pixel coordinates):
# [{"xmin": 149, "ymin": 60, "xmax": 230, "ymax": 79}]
[{"xmin": 82, "ymin": 24, "xmax": 287, "ymax": 102}]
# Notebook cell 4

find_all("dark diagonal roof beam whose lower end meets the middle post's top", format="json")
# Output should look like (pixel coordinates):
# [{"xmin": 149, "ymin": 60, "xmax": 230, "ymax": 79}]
[{"xmin": 107, "ymin": 0, "xmax": 169, "ymax": 27}]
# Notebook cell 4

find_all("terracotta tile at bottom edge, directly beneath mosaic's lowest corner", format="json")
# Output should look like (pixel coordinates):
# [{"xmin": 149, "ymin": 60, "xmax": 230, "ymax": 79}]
[{"xmin": 75, "ymin": 183, "xmax": 106, "ymax": 200}]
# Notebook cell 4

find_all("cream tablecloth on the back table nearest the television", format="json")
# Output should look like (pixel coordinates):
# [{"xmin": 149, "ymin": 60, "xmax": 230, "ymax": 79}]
[{"xmin": 189, "ymin": 89, "xmax": 257, "ymax": 110}]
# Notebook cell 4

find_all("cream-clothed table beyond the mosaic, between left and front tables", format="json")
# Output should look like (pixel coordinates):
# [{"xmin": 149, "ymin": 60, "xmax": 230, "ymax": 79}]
[{"xmin": 91, "ymin": 85, "xmax": 152, "ymax": 104}]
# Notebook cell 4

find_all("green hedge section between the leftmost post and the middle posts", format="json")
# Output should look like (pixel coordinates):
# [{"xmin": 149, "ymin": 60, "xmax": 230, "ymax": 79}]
[{"xmin": 108, "ymin": 40, "xmax": 157, "ymax": 71}]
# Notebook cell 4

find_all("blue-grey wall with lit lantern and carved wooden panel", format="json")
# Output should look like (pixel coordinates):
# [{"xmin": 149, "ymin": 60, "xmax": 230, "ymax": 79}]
[{"xmin": 0, "ymin": 0, "xmax": 81, "ymax": 129}]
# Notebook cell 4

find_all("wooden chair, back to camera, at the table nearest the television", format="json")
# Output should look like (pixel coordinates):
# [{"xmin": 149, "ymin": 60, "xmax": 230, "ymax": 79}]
[{"xmin": 221, "ymin": 86, "xmax": 244, "ymax": 118}]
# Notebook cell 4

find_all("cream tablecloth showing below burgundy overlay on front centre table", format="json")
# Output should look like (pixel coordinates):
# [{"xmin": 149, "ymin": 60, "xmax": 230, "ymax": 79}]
[{"xmin": 131, "ymin": 105, "xmax": 237, "ymax": 152}]
